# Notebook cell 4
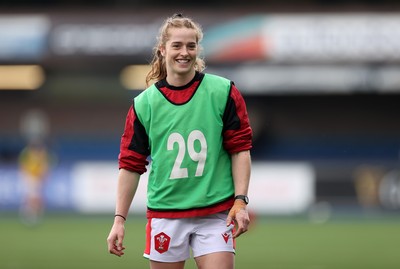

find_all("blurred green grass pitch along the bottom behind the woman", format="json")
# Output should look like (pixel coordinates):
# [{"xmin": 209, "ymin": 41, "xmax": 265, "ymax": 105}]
[{"xmin": 0, "ymin": 215, "xmax": 400, "ymax": 269}]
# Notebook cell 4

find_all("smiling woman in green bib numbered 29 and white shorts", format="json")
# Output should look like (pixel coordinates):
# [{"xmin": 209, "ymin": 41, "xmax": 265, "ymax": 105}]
[{"xmin": 107, "ymin": 14, "xmax": 252, "ymax": 269}]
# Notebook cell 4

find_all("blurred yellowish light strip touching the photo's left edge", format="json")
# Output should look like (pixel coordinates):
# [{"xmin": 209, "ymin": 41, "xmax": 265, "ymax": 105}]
[{"xmin": 0, "ymin": 65, "xmax": 45, "ymax": 90}]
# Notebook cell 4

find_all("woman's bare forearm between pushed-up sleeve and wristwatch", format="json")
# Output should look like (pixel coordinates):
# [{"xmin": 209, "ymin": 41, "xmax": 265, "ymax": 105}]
[{"xmin": 231, "ymin": 150, "xmax": 251, "ymax": 195}]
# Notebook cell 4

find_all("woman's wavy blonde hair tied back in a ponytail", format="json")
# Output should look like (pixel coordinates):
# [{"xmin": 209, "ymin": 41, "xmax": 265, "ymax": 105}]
[{"xmin": 146, "ymin": 14, "xmax": 205, "ymax": 86}]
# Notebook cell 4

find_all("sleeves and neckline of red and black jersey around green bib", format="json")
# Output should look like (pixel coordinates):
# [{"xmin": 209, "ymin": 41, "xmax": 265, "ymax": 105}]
[{"xmin": 118, "ymin": 73, "xmax": 252, "ymax": 174}]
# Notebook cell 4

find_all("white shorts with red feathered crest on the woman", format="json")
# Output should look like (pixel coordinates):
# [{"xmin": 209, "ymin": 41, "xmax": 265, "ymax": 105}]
[{"xmin": 143, "ymin": 212, "xmax": 235, "ymax": 262}]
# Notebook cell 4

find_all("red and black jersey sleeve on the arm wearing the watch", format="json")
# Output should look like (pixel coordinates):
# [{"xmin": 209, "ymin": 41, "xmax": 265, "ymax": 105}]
[{"xmin": 223, "ymin": 83, "xmax": 253, "ymax": 154}]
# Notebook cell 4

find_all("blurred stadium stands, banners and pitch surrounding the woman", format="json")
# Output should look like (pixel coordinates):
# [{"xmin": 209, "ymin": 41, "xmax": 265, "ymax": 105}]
[{"xmin": 0, "ymin": 0, "xmax": 400, "ymax": 268}]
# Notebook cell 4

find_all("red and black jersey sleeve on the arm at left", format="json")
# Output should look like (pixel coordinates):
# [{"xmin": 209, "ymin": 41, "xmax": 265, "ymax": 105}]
[{"xmin": 118, "ymin": 105, "xmax": 150, "ymax": 174}]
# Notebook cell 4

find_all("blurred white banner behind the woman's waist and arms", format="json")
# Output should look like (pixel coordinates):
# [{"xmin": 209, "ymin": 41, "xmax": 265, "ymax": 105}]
[{"xmin": 71, "ymin": 162, "xmax": 315, "ymax": 214}]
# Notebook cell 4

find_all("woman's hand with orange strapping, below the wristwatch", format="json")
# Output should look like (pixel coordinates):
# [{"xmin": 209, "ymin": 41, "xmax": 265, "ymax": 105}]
[{"xmin": 226, "ymin": 199, "xmax": 250, "ymax": 238}]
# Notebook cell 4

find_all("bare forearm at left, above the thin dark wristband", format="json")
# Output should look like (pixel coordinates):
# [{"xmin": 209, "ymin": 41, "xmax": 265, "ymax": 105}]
[{"xmin": 115, "ymin": 169, "xmax": 140, "ymax": 218}]
